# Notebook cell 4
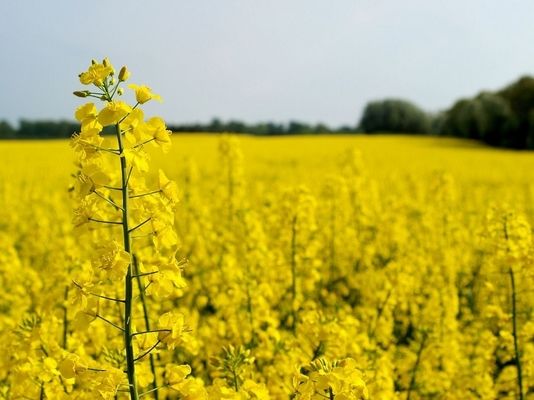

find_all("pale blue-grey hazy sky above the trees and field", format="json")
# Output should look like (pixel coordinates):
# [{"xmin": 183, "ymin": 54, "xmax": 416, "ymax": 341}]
[{"xmin": 0, "ymin": 0, "xmax": 534, "ymax": 126}]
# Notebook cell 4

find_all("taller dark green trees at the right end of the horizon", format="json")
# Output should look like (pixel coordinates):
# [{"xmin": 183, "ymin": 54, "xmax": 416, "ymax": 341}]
[{"xmin": 359, "ymin": 76, "xmax": 534, "ymax": 149}]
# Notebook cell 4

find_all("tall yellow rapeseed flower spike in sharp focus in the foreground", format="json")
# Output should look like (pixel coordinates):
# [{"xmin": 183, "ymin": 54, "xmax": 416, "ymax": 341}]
[{"xmin": 68, "ymin": 59, "xmax": 199, "ymax": 400}]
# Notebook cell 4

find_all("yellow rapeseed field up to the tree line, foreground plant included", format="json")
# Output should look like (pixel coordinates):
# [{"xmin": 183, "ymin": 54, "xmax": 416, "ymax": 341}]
[{"xmin": 0, "ymin": 60, "xmax": 534, "ymax": 400}]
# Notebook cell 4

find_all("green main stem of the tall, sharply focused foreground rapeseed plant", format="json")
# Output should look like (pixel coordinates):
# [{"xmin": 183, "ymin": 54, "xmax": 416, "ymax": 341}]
[{"xmin": 115, "ymin": 124, "xmax": 139, "ymax": 400}]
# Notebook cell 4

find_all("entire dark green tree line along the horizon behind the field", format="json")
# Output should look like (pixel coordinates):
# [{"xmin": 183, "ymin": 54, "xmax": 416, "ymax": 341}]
[{"xmin": 0, "ymin": 76, "xmax": 534, "ymax": 149}]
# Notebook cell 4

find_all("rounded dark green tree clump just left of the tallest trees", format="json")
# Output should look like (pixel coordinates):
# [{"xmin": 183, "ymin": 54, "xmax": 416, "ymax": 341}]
[{"xmin": 360, "ymin": 99, "xmax": 430, "ymax": 133}]
